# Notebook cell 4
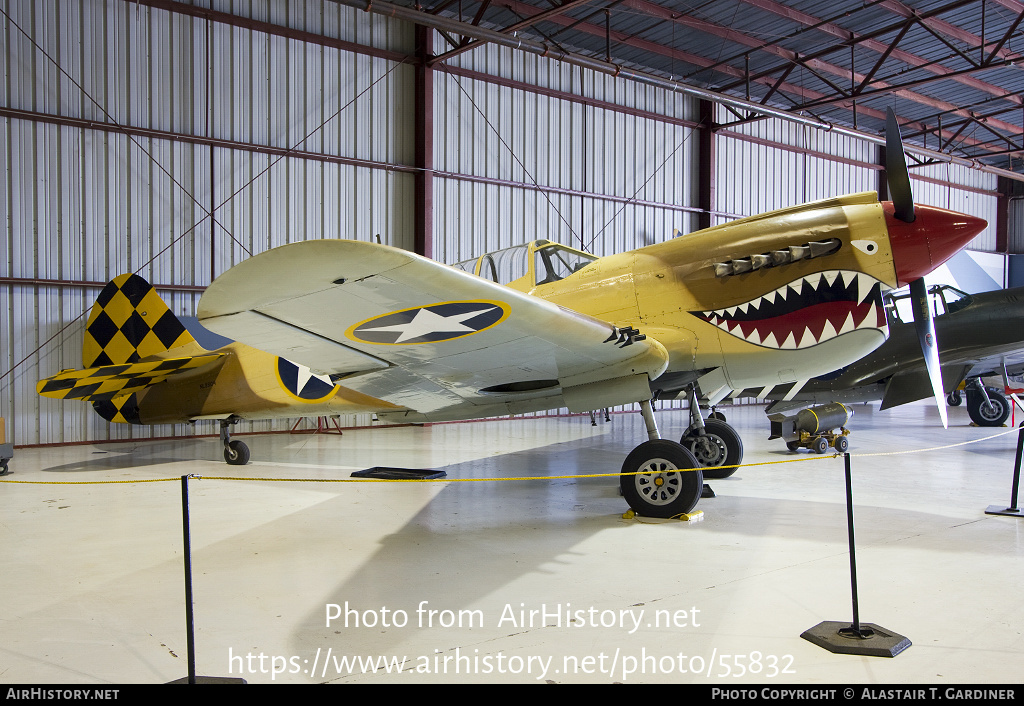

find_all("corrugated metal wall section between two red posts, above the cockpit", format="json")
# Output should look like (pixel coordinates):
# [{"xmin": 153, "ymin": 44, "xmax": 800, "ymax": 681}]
[{"xmin": 434, "ymin": 45, "xmax": 696, "ymax": 262}]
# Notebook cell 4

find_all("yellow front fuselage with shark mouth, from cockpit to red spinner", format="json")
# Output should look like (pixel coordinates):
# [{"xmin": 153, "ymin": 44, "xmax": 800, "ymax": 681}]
[{"xmin": 532, "ymin": 189, "xmax": 897, "ymax": 392}]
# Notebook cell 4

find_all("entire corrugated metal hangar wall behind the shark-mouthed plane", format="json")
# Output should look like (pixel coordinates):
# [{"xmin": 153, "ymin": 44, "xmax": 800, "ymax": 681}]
[{"xmin": 0, "ymin": 0, "xmax": 1007, "ymax": 445}]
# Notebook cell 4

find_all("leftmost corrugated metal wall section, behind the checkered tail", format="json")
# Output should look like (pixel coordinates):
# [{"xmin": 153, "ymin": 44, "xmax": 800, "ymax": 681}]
[{"xmin": 0, "ymin": 0, "xmax": 414, "ymax": 444}]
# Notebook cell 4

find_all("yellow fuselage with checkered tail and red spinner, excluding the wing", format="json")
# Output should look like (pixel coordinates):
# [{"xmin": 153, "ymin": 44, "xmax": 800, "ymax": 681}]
[{"xmin": 39, "ymin": 189, "xmax": 985, "ymax": 424}]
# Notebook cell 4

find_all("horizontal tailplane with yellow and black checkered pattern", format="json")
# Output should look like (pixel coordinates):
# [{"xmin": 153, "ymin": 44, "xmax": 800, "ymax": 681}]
[{"xmin": 36, "ymin": 354, "xmax": 222, "ymax": 402}]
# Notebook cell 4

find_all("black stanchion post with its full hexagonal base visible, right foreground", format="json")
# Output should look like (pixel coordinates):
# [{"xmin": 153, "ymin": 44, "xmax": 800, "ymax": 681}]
[{"xmin": 800, "ymin": 453, "xmax": 910, "ymax": 657}]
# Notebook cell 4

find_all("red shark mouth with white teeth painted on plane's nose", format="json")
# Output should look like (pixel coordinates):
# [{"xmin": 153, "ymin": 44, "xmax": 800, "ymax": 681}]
[{"xmin": 690, "ymin": 269, "xmax": 889, "ymax": 349}]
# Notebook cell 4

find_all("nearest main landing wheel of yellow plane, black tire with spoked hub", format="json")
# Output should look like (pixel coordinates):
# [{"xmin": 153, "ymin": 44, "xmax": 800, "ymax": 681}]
[{"xmin": 618, "ymin": 439, "xmax": 703, "ymax": 517}]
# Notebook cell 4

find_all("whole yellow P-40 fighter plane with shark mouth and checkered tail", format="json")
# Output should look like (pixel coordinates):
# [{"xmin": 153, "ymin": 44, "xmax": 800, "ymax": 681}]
[{"xmin": 39, "ymin": 112, "xmax": 985, "ymax": 516}]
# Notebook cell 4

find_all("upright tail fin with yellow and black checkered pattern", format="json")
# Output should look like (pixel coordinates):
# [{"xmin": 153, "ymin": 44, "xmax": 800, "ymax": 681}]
[{"xmin": 82, "ymin": 275, "xmax": 196, "ymax": 368}]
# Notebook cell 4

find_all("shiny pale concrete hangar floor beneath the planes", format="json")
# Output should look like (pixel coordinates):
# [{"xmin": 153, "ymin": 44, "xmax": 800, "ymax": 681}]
[{"xmin": 0, "ymin": 405, "xmax": 1024, "ymax": 687}]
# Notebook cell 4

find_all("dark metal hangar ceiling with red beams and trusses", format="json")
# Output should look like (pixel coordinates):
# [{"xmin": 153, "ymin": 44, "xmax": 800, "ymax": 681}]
[{"xmin": 341, "ymin": 0, "xmax": 1024, "ymax": 180}]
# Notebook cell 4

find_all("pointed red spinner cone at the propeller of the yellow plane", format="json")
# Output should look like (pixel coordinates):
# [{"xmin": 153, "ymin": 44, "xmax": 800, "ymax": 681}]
[{"xmin": 882, "ymin": 202, "xmax": 988, "ymax": 285}]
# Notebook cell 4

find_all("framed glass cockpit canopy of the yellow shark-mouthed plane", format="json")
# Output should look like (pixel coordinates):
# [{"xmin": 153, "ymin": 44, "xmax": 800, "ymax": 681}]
[{"xmin": 452, "ymin": 240, "xmax": 597, "ymax": 292}]
